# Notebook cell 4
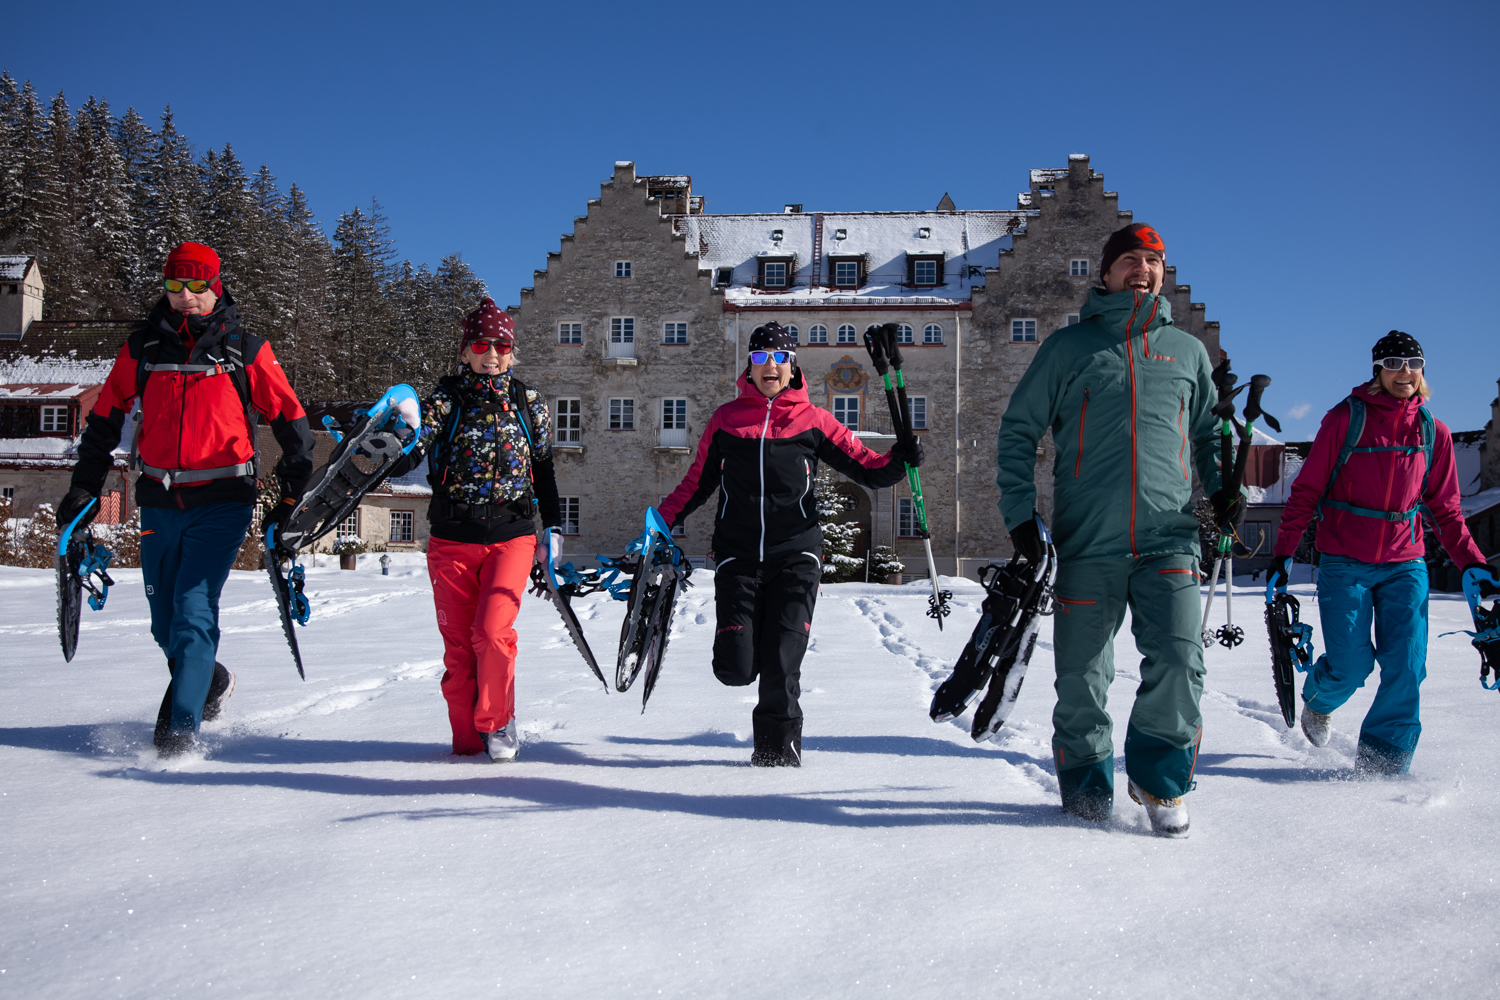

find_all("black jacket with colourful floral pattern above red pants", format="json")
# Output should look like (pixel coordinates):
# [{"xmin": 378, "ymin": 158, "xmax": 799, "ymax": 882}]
[{"xmin": 417, "ymin": 370, "xmax": 560, "ymax": 526}]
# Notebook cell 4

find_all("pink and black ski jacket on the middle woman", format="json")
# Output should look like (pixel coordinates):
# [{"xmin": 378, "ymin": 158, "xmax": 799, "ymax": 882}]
[{"xmin": 659, "ymin": 372, "xmax": 906, "ymax": 562}]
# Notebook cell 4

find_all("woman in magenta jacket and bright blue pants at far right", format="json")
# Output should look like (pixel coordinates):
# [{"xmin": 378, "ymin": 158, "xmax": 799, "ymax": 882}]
[{"xmin": 1271, "ymin": 330, "xmax": 1494, "ymax": 774}]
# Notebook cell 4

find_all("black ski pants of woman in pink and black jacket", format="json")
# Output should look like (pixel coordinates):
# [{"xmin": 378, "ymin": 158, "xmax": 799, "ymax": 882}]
[{"xmin": 714, "ymin": 552, "xmax": 824, "ymax": 732}]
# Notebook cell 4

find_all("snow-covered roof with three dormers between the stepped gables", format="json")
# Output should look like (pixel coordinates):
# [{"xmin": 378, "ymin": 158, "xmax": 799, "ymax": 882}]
[{"xmin": 674, "ymin": 211, "xmax": 1035, "ymax": 306}]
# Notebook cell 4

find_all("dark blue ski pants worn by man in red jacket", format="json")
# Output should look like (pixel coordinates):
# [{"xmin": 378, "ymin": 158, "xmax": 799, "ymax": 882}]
[{"xmin": 141, "ymin": 504, "xmax": 251, "ymax": 733}]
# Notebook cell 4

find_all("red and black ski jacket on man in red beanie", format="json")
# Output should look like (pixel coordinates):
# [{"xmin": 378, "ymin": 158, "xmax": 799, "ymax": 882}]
[{"xmin": 72, "ymin": 295, "xmax": 312, "ymax": 508}]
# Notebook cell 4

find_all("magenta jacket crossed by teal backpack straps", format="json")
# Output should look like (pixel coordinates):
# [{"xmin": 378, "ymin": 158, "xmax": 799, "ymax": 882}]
[{"xmin": 1275, "ymin": 385, "xmax": 1485, "ymax": 567}]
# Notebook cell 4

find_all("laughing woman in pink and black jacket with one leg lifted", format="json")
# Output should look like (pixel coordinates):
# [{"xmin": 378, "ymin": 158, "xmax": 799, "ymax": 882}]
[{"xmin": 660, "ymin": 322, "xmax": 923, "ymax": 768}]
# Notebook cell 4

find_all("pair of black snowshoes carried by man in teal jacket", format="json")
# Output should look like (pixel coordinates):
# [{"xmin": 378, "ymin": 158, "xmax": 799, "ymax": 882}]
[{"xmin": 927, "ymin": 519, "xmax": 1058, "ymax": 742}]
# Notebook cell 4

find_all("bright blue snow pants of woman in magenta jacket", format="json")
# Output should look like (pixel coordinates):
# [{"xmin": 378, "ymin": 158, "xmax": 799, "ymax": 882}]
[{"xmin": 1302, "ymin": 556, "xmax": 1428, "ymax": 774}]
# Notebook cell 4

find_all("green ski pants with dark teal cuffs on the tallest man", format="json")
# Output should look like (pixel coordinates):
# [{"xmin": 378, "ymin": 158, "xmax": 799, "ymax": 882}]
[{"xmin": 1052, "ymin": 555, "xmax": 1205, "ymax": 814}]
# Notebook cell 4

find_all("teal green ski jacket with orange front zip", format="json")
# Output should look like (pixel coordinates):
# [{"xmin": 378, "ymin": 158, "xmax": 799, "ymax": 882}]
[{"xmin": 995, "ymin": 289, "xmax": 1220, "ymax": 561}]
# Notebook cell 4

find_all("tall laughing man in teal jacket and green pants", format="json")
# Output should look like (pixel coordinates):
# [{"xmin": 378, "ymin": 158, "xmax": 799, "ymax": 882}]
[{"xmin": 996, "ymin": 223, "xmax": 1244, "ymax": 837}]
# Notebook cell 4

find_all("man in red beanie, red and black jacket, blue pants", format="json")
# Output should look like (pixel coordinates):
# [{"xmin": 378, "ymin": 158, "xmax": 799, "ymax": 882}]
[{"xmin": 57, "ymin": 243, "xmax": 312, "ymax": 757}]
